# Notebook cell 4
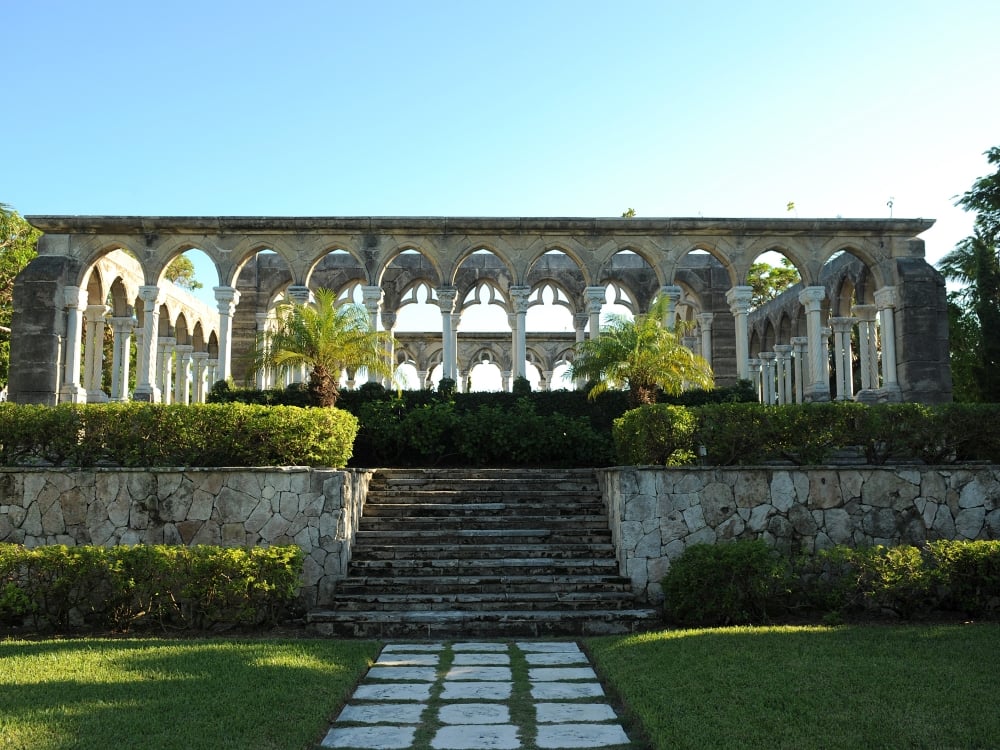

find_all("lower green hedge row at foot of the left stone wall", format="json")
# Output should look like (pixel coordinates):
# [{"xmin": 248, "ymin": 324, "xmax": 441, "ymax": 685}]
[{"xmin": 0, "ymin": 543, "xmax": 303, "ymax": 632}]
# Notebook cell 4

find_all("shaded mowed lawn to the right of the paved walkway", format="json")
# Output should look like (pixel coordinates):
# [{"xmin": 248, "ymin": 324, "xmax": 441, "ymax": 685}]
[{"xmin": 587, "ymin": 624, "xmax": 1000, "ymax": 750}]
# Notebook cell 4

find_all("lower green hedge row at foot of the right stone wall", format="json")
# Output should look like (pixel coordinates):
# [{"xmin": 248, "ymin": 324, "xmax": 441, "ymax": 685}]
[{"xmin": 663, "ymin": 540, "xmax": 1000, "ymax": 627}]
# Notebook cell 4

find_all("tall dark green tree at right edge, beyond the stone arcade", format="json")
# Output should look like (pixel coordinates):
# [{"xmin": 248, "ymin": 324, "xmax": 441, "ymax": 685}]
[{"xmin": 938, "ymin": 147, "xmax": 1000, "ymax": 402}]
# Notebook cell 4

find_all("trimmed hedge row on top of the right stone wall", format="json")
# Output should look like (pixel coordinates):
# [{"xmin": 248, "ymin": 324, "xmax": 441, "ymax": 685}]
[{"xmin": 613, "ymin": 402, "xmax": 1000, "ymax": 466}]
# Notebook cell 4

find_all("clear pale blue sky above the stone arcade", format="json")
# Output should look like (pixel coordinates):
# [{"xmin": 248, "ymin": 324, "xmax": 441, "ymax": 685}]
[{"xmin": 0, "ymin": 0, "xmax": 1000, "ymax": 262}]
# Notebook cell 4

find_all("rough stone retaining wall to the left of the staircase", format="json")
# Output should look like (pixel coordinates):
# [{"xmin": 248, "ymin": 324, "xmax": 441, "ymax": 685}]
[{"xmin": 0, "ymin": 467, "xmax": 371, "ymax": 606}]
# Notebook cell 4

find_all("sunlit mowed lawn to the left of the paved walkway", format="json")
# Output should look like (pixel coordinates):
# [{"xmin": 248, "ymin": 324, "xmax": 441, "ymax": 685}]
[{"xmin": 0, "ymin": 638, "xmax": 379, "ymax": 750}]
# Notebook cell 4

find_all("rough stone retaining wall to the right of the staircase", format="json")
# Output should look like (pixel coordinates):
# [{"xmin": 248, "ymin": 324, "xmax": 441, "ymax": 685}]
[{"xmin": 598, "ymin": 466, "xmax": 1000, "ymax": 602}]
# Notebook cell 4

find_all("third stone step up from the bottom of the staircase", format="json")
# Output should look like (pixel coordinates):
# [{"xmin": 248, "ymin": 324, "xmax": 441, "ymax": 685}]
[{"xmin": 337, "ymin": 575, "xmax": 632, "ymax": 597}]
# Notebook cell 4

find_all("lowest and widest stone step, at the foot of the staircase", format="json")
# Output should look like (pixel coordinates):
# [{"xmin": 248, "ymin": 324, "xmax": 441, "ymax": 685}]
[{"xmin": 306, "ymin": 608, "xmax": 662, "ymax": 639}]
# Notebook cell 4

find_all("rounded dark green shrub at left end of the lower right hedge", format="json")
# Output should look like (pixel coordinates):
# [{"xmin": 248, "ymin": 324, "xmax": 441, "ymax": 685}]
[{"xmin": 663, "ymin": 540, "xmax": 789, "ymax": 626}]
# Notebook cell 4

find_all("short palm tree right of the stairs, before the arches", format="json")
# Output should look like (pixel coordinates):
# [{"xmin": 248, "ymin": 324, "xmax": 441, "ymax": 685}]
[{"xmin": 570, "ymin": 297, "xmax": 714, "ymax": 406}]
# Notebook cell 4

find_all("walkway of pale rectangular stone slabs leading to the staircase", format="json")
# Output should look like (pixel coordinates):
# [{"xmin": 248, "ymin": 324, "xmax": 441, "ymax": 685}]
[{"xmin": 322, "ymin": 641, "xmax": 629, "ymax": 750}]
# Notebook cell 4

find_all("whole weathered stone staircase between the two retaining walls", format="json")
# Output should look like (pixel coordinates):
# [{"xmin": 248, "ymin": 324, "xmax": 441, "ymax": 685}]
[{"xmin": 307, "ymin": 469, "xmax": 659, "ymax": 638}]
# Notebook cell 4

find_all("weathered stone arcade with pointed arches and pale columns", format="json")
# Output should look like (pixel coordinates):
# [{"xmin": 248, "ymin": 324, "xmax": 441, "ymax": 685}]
[{"xmin": 10, "ymin": 216, "xmax": 951, "ymax": 403}]
